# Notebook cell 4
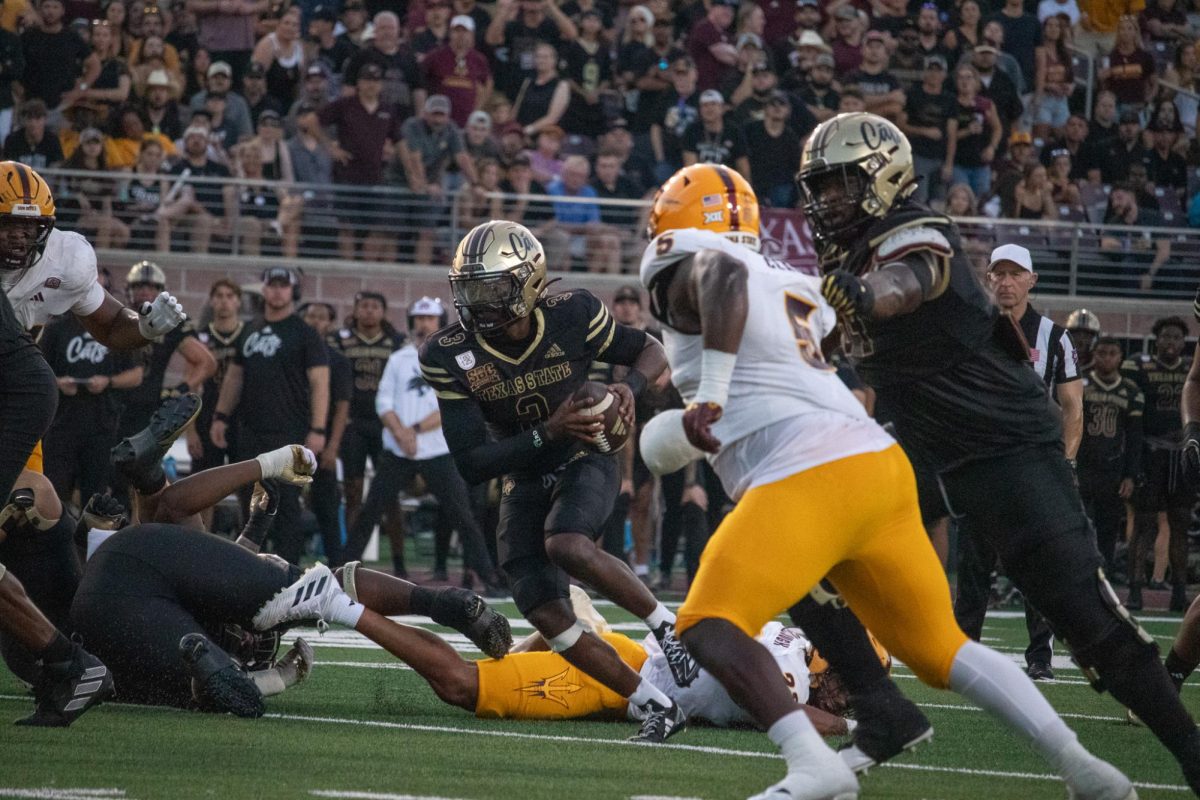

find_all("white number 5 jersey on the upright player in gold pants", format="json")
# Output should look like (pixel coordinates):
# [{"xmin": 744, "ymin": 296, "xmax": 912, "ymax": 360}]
[{"xmin": 642, "ymin": 229, "xmax": 894, "ymax": 500}]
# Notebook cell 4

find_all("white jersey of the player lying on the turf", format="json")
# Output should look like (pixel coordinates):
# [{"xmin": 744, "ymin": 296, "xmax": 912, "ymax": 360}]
[{"xmin": 631, "ymin": 621, "xmax": 809, "ymax": 727}]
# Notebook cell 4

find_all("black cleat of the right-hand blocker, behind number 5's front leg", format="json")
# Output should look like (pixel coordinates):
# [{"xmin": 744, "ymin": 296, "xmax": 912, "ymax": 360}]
[{"xmin": 838, "ymin": 681, "xmax": 934, "ymax": 774}]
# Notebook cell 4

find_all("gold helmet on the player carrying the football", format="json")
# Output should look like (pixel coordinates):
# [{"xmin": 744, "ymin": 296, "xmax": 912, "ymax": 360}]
[{"xmin": 450, "ymin": 219, "xmax": 548, "ymax": 335}]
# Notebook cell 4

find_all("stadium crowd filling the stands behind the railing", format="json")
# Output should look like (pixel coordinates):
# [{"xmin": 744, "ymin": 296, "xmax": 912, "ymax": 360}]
[{"xmin": 0, "ymin": 0, "xmax": 1200, "ymax": 283}]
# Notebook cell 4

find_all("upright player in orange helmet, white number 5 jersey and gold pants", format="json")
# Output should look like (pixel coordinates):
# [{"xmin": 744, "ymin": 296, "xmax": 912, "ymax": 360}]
[{"xmin": 641, "ymin": 164, "xmax": 1136, "ymax": 800}]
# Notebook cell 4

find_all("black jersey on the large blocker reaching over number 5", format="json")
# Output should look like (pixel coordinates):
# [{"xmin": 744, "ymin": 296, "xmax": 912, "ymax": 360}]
[{"xmin": 822, "ymin": 201, "xmax": 1062, "ymax": 471}]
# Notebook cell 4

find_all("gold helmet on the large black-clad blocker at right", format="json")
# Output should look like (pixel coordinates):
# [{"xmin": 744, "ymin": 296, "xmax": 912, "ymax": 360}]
[{"xmin": 796, "ymin": 112, "xmax": 917, "ymax": 255}]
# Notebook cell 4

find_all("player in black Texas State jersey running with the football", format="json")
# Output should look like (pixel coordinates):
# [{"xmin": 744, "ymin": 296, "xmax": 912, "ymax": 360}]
[{"xmin": 420, "ymin": 221, "xmax": 698, "ymax": 741}]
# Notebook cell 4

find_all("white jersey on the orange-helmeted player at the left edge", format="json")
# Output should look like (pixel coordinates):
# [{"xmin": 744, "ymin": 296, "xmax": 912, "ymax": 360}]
[{"xmin": 2, "ymin": 228, "xmax": 104, "ymax": 330}]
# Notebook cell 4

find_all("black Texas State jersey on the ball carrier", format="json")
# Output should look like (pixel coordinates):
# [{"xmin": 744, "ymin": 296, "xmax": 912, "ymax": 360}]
[{"xmin": 421, "ymin": 290, "xmax": 646, "ymax": 472}]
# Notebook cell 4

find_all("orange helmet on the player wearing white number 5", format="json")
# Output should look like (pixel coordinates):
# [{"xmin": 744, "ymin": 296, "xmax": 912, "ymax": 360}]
[{"xmin": 647, "ymin": 164, "xmax": 760, "ymax": 249}]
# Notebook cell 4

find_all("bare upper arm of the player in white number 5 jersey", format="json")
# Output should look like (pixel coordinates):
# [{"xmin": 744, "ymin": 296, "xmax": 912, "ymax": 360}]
[{"xmin": 690, "ymin": 249, "xmax": 750, "ymax": 353}]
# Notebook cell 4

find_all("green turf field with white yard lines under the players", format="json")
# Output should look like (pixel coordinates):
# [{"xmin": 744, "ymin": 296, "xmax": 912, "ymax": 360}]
[{"xmin": 0, "ymin": 603, "xmax": 1200, "ymax": 800}]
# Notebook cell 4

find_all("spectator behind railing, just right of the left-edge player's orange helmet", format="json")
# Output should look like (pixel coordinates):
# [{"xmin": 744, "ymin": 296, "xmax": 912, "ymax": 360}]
[{"xmin": 55, "ymin": 128, "xmax": 130, "ymax": 249}]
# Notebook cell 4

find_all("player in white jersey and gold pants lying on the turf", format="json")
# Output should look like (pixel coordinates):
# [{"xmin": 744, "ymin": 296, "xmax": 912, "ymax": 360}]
[{"xmin": 340, "ymin": 575, "xmax": 868, "ymax": 736}]
